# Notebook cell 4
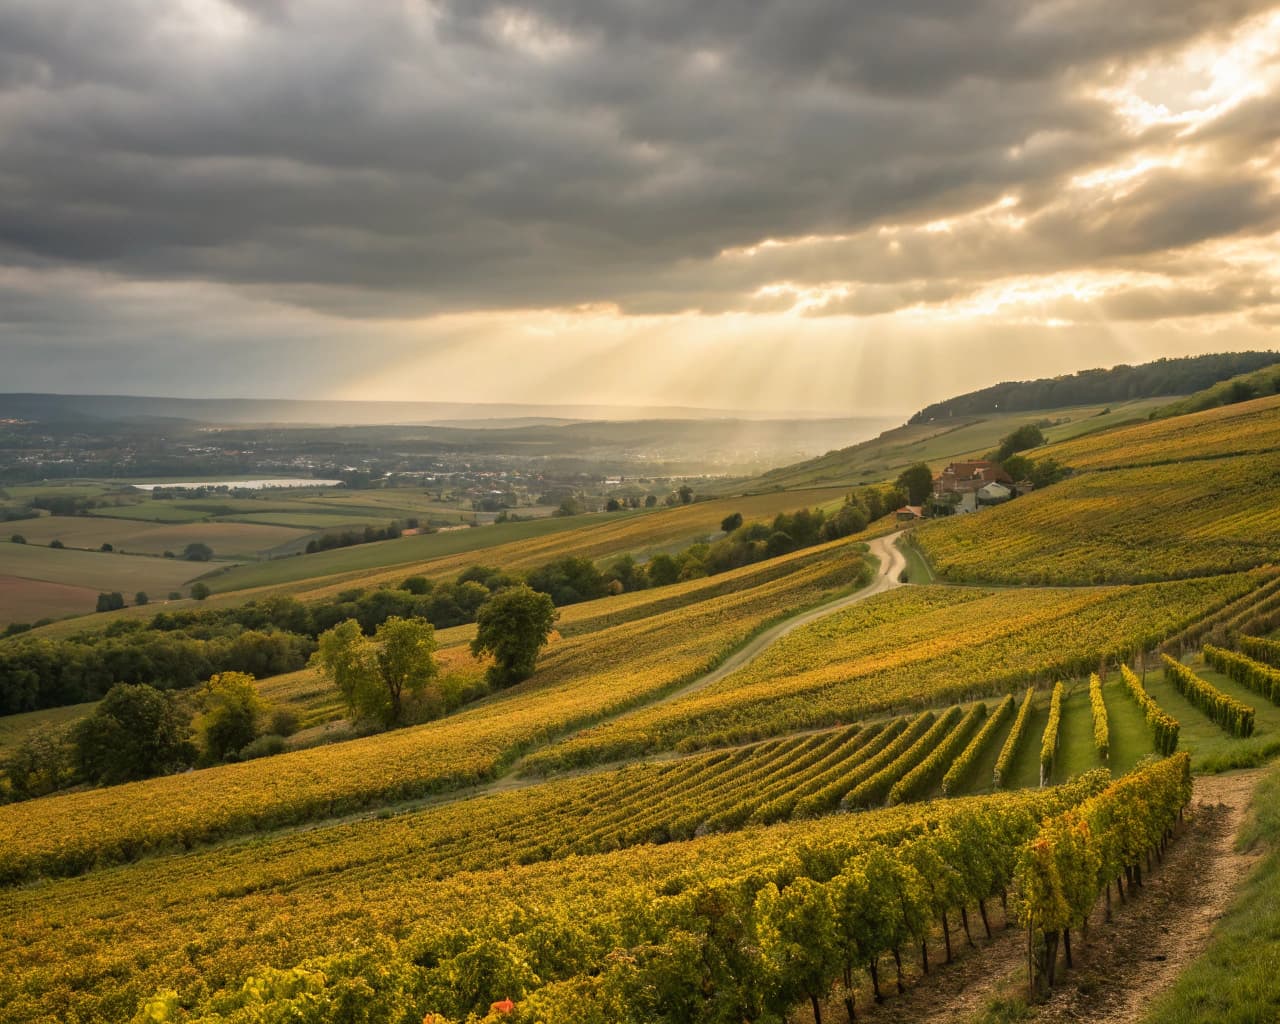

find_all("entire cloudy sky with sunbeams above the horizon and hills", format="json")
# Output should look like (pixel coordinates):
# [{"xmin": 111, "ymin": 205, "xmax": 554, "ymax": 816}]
[{"xmin": 0, "ymin": 0, "xmax": 1280, "ymax": 415}]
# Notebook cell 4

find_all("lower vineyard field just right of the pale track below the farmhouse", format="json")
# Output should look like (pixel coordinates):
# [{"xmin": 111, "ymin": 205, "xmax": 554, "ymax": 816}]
[{"xmin": 915, "ymin": 453, "xmax": 1280, "ymax": 585}]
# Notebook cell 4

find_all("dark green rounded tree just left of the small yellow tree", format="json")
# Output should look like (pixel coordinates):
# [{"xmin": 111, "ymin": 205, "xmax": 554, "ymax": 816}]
[{"xmin": 72, "ymin": 682, "xmax": 196, "ymax": 785}]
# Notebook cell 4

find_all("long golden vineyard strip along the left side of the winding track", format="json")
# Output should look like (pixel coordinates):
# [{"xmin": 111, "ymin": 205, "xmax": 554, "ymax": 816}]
[{"xmin": 0, "ymin": 545, "xmax": 865, "ymax": 881}]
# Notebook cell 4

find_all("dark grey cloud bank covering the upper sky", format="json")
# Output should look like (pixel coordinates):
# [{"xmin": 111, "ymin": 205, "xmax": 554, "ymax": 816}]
[{"xmin": 0, "ymin": 0, "xmax": 1275, "ymax": 317}]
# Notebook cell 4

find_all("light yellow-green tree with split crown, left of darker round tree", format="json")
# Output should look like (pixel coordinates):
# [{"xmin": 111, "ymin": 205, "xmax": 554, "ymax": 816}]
[{"xmin": 312, "ymin": 616, "xmax": 436, "ymax": 726}]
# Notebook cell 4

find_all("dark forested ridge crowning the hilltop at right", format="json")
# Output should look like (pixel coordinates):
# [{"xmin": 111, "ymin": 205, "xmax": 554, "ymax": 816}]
[{"xmin": 908, "ymin": 352, "xmax": 1280, "ymax": 424}]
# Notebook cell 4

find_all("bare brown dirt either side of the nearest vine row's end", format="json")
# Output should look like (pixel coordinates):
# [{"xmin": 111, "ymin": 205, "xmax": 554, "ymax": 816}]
[{"xmin": 823, "ymin": 769, "xmax": 1265, "ymax": 1024}]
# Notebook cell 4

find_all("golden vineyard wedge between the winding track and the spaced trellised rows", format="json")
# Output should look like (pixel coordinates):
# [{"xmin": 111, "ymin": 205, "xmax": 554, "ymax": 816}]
[{"xmin": 526, "ymin": 576, "xmax": 1256, "ymax": 772}]
